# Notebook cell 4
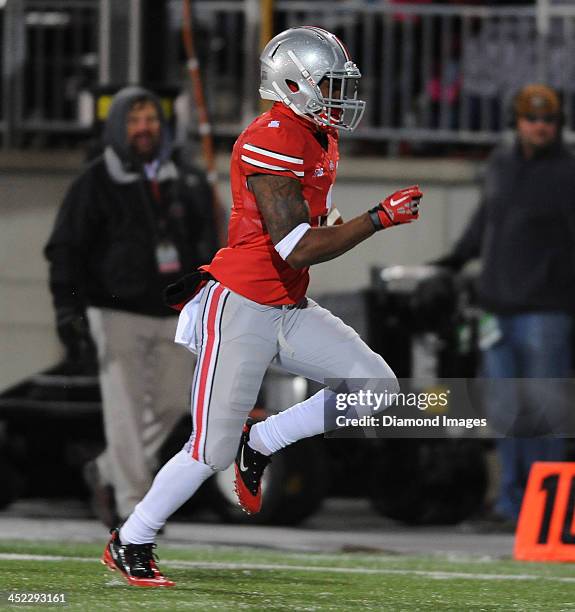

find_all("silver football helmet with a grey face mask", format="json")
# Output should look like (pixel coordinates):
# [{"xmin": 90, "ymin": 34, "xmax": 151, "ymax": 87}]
[{"xmin": 260, "ymin": 26, "xmax": 365, "ymax": 131}]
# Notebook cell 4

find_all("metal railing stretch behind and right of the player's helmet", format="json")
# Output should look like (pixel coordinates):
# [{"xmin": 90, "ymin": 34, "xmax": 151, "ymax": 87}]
[{"xmin": 190, "ymin": 0, "xmax": 575, "ymax": 144}]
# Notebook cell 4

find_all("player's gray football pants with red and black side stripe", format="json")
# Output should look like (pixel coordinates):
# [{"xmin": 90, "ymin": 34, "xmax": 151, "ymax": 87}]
[{"xmin": 186, "ymin": 281, "xmax": 398, "ymax": 470}]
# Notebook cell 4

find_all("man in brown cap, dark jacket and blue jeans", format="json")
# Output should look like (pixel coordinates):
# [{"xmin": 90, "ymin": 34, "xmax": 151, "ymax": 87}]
[{"xmin": 436, "ymin": 84, "xmax": 575, "ymax": 526}]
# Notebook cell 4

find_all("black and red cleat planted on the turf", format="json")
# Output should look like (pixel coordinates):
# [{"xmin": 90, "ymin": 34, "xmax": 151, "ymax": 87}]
[{"xmin": 100, "ymin": 529, "xmax": 176, "ymax": 587}]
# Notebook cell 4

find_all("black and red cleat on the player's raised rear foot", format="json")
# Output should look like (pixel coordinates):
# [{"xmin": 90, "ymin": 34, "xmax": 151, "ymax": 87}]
[{"xmin": 234, "ymin": 419, "xmax": 270, "ymax": 514}]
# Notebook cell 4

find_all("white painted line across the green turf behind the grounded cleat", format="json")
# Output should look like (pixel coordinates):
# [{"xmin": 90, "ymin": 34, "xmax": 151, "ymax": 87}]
[{"xmin": 0, "ymin": 553, "xmax": 575, "ymax": 584}]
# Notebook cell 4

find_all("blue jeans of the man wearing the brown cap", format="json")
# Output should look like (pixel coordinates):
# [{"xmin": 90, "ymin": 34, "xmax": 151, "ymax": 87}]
[{"xmin": 483, "ymin": 312, "xmax": 572, "ymax": 519}]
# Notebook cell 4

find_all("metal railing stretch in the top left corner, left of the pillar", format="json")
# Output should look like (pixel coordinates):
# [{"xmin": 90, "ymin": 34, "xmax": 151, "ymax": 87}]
[{"xmin": 0, "ymin": 0, "xmax": 99, "ymax": 146}]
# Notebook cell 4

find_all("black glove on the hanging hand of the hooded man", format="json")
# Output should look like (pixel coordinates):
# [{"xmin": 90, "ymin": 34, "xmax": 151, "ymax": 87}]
[{"xmin": 56, "ymin": 308, "xmax": 98, "ymax": 371}]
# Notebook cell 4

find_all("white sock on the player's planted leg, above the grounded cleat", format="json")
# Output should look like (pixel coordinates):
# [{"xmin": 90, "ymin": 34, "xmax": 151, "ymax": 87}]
[{"xmin": 120, "ymin": 449, "xmax": 214, "ymax": 544}]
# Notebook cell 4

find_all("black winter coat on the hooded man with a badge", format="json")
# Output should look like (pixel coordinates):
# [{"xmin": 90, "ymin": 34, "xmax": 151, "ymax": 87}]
[{"xmin": 45, "ymin": 156, "xmax": 217, "ymax": 316}]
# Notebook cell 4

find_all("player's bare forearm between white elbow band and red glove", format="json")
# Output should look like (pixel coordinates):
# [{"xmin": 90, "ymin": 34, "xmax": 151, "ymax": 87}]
[{"xmin": 286, "ymin": 213, "xmax": 375, "ymax": 269}]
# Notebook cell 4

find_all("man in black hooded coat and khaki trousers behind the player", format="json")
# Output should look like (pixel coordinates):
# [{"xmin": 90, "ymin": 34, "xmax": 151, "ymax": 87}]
[{"xmin": 45, "ymin": 87, "xmax": 217, "ymax": 526}]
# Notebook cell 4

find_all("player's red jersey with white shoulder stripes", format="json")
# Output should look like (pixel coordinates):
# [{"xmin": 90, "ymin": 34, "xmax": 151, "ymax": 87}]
[{"xmin": 204, "ymin": 102, "xmax": 339, "ymax": 305}]
